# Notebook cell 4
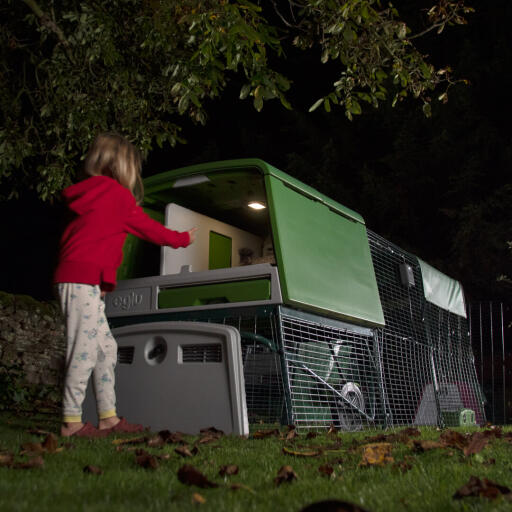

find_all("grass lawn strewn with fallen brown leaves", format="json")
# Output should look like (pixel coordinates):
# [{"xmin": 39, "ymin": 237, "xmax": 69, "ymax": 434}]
[{"xmin": 0, "ymin": 413, "xmax": 512, "ymax": 512}]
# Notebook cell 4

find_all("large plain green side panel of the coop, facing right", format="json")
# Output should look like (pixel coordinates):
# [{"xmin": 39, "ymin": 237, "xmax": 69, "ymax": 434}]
[{"xmin": 265, "ymin": 175, "xmax": 384, "ymax": 326}]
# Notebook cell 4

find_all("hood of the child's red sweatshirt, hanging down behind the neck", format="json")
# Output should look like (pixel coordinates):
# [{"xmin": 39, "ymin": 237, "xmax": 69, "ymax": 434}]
[{"xmin": 62, "ymin": 176, "xmax": 119, "ymax": 215}]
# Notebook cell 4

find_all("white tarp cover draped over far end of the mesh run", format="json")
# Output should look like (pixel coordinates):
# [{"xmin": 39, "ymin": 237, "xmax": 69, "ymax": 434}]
[{"xmin": 418, "ymin": 258, "xmax": 466, "ymax": 318}]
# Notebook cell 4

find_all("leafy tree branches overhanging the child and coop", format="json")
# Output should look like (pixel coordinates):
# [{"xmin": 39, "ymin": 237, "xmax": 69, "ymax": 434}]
[{"xmin": 0, "ymin": 0, "xmax": 471, "ymax": 199}]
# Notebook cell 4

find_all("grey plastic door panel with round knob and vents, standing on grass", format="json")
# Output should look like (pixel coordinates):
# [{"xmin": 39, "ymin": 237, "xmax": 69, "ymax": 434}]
[{"xmin": 83, "ymin": 322, "xmax": 249, "ymax": 435}]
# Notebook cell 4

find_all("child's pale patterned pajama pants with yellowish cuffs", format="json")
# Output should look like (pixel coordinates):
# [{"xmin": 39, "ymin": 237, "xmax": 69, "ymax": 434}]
[{"xmin": 57, "ymin": 283, "xmax": 117, "ymax": 422}]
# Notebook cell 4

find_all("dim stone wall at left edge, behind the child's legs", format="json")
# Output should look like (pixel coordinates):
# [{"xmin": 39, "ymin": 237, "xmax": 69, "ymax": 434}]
[{"xmin": 0, "ymin": 292, "xmax": 66, "ymax": 408}]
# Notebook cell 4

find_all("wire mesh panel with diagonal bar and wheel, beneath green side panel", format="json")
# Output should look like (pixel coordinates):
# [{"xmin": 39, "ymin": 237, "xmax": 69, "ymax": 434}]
[{"xmin": 281, "ymin": 315, "xmax": 383, "ymax": 430}]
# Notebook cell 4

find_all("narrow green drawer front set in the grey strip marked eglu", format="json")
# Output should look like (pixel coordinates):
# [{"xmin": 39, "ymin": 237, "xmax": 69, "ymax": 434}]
[{"xmin": 158, "ymin": 279, "xmax": 270, "ymax": 309}]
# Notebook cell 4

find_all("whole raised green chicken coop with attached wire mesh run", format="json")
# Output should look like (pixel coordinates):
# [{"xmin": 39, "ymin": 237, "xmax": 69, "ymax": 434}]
[{"xmin": 90, "ymin": 159, "xmax": 485, "ymax": 434}]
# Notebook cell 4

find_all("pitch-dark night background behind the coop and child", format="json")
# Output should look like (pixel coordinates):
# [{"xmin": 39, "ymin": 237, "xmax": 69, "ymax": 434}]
[{"xmin": 0, "ymin": 0, "xmax": 512, "ymax": 301}]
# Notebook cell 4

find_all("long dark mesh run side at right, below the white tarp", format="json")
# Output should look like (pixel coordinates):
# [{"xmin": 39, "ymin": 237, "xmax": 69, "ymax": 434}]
[{"xmin": 368, "ymin": 231, "xmax": 485, "ymax": 425}]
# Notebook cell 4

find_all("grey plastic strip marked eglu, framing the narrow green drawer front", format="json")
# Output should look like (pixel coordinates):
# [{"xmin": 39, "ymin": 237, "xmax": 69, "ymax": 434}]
[{"xmin": 105, "ymin": 263, "xmax": 283, "ymax": 318}]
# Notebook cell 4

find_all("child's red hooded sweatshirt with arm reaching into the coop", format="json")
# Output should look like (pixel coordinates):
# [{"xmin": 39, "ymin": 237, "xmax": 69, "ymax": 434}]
[{"xmin": 53, "ymin": 176, "xmax": 190, "ymax": 291}]
